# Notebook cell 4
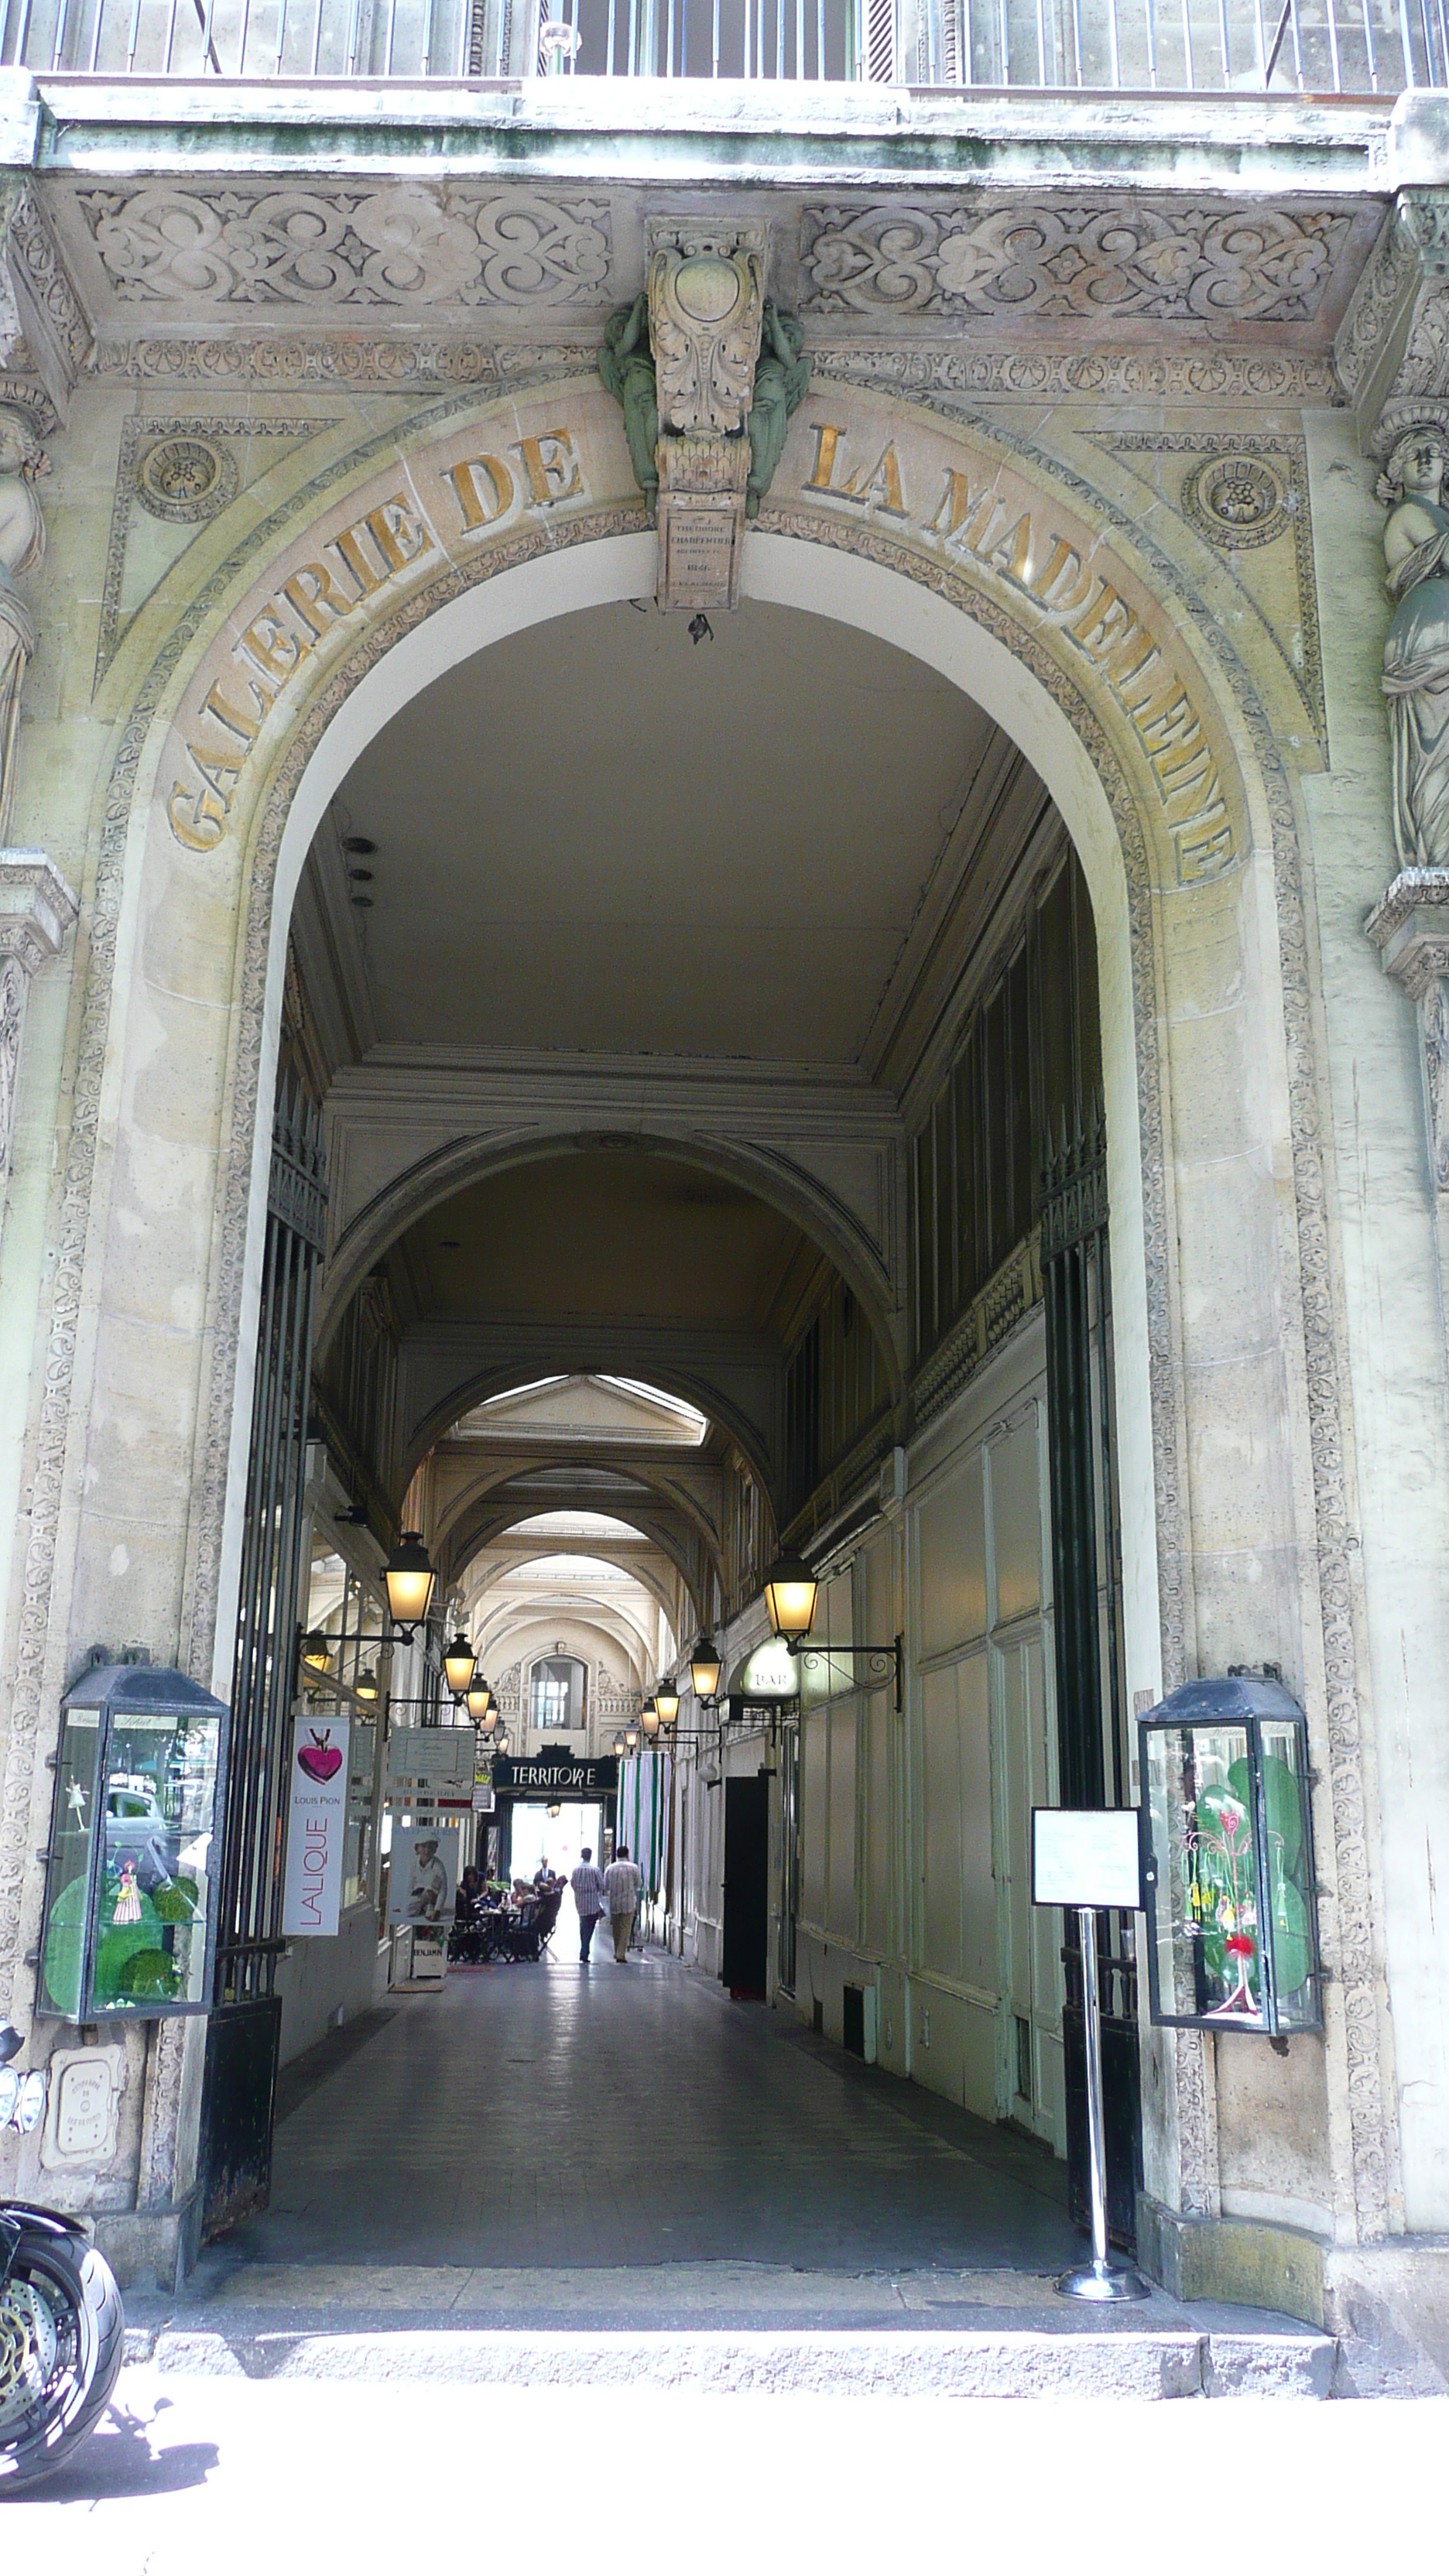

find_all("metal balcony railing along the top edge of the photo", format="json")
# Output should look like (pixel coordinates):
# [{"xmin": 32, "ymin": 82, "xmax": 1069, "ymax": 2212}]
[{"xmin": 0, "ymin": 0, "xmax": 1423, "ymax": 98}]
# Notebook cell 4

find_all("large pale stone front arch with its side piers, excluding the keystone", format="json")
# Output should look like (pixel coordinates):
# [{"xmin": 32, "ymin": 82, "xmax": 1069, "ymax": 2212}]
[{"xmin": 13, "ymin": 363, "xmax": 1377, "ymax": 2256}]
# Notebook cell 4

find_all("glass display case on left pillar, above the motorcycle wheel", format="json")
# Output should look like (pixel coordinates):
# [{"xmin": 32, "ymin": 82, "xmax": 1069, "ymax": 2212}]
[{"xmin": 36, "ymin": 1664, "xmax": 227, "ymax": 2022}]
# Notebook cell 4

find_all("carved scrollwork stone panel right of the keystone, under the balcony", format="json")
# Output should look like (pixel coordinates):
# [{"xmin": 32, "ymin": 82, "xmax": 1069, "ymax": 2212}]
[{"xmin": 800, "ymin": 196, "xmax": 1354, "ymax": 337}]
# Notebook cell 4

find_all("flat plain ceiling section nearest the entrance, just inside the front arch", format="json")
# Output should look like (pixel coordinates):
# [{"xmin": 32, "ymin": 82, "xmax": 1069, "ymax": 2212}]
[{"xmin": 312, "ymin": 603, "xmax": 992, "ymax": 1064}]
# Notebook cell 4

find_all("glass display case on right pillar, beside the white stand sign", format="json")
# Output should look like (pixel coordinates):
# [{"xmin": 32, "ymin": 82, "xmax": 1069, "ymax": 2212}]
[{"xmin": 1139, "ymin": 1674, "xmax": 1323, "ymax": 2037}]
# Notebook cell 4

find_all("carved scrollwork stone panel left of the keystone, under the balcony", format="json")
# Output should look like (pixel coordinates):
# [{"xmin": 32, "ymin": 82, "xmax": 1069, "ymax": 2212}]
[{"xmin": 75, "ymin": 180, "xmax": 611, "ymax": 320}]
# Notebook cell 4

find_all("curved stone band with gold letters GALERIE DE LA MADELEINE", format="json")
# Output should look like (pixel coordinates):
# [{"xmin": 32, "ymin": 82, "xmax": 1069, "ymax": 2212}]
[{"xmin": 163, "ymin": 386, "xmax": 1245, "ymax": 881}]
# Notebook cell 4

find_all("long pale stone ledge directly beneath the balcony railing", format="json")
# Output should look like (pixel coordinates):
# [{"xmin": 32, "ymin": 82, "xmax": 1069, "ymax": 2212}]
[{"xmin": 16, "ymin": 70, "xmax": 1392, "ymax": 196}]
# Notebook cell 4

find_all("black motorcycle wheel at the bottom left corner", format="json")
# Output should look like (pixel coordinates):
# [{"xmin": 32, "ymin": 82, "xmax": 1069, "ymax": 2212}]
[{"xmin": 0, "ymin": 2231, "xmax": 126, "ymax": 2496}]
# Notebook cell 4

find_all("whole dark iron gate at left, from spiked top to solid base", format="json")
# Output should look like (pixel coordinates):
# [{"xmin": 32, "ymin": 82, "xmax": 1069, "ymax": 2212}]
[{"xmin": 201, "ymin": 1082, "xmax": 327, "ymax": 2236}]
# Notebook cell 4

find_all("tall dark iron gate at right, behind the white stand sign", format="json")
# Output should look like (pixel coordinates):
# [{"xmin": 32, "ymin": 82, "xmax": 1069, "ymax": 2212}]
[{"xmin": 1042, "ymin": 1102, "xmax": 1142, "ymax": 2246}]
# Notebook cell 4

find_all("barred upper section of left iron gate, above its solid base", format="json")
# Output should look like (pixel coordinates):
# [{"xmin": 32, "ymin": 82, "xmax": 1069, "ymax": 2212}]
[{"xmin": 217, "ymin": 1082, "xmax": 327, "ymax": 2004}]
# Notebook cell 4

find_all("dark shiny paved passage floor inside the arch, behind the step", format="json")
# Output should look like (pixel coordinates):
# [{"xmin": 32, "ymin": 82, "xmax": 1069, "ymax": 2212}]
[{"xmin": 229, "ymin": 1953, "xmax": 1081, "ymax": 2277}]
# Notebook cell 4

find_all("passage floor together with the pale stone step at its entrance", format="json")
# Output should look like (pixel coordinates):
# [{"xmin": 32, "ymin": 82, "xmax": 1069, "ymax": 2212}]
[{"xmin": 112, "ymin": 1953, "xmax": 1335, "ymax": 2398}]
